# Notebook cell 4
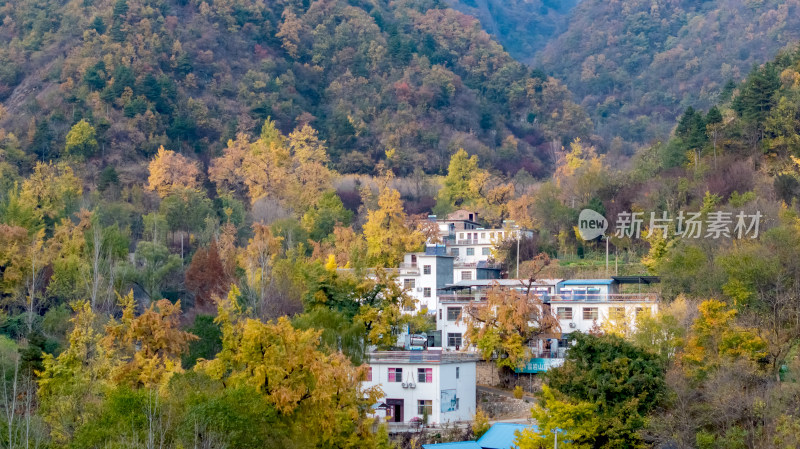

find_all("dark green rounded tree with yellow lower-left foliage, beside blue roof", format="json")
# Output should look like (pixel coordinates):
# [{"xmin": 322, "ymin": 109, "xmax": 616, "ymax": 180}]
[{"xmin": 519, "ymin": 334, "xmax": 667, "ymax": 449}]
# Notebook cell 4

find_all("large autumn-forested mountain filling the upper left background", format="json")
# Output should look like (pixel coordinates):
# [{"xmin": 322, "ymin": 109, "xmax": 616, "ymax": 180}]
[{"xmin": 0, "ymin": 0, "xmax": 591, "ymax": 175}]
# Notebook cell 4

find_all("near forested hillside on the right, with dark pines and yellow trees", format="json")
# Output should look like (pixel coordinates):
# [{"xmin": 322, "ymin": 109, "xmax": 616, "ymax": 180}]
[{"xmin": 519, "ymin": 44, "xmax": 800, "ymax": 449}]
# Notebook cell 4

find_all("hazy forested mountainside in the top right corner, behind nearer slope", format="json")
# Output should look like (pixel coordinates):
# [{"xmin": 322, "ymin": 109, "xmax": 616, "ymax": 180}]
[{"xmin": 535, "ymin": 0, "xmax": 800, "ymax": 142}]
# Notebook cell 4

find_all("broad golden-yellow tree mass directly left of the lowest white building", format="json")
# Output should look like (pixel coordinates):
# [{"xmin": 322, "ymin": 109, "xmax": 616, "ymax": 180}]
[{"xmin": 195, "ymin": 287, "xmax": 381, "ymax": 448}]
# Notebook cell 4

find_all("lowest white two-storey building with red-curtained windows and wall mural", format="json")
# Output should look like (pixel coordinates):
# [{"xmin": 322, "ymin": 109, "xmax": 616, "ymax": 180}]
[{"xmin": 363, "ymin": 350, "xmax": 478, "ymax": 425}]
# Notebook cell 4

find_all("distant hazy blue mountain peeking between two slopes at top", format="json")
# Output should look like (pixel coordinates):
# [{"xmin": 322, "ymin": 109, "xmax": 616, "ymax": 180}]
[{"xmin": 448, "ymin": 0, "xmax": 580, "ymax": 63}]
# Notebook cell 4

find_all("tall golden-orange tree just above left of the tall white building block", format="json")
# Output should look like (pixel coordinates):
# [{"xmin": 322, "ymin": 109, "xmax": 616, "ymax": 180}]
[{"xmin": 364, "ymin": 186, "xmax": 424, "ymax": 267}]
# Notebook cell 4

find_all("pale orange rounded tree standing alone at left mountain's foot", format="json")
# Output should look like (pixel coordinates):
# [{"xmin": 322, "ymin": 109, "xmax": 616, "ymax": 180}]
[{"xmin": 147, "ymin": 146, "xmax": 200, "ymax": 198}]
